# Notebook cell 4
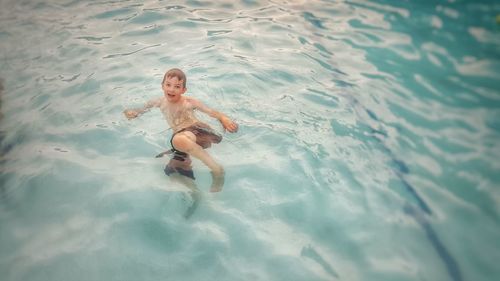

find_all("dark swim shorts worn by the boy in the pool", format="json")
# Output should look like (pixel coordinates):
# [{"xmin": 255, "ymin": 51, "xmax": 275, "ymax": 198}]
[{"xmin": 164, "ymin": 122, "xmax": 222, "ymax": 179}]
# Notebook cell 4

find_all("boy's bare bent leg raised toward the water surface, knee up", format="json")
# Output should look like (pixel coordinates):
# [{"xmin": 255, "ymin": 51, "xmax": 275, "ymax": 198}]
[{"xmin": 172, "ymin": 131, "xmax": 224, "ymax": 191}]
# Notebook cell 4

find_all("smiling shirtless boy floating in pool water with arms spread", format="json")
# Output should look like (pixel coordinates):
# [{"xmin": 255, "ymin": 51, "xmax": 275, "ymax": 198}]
[{"xmin": 124, "ymin": 68, "xmax": 238, "ymax": 192}]
